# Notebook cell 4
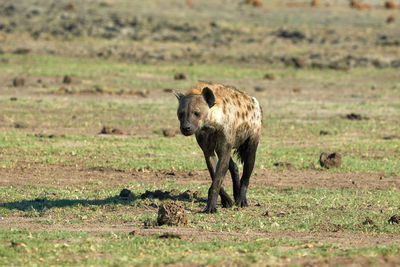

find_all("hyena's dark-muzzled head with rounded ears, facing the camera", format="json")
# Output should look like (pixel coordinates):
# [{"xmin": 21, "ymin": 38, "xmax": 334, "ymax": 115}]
[{"xmin": 175, "ymin": 87, "xmax": 215, "ymax": 136}]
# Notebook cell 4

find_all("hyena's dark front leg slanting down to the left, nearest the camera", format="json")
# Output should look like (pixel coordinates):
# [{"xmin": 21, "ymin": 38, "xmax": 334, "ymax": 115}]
[{"xmin": 204, "ymin": 144, "xmax": 232, "ymax": 213}]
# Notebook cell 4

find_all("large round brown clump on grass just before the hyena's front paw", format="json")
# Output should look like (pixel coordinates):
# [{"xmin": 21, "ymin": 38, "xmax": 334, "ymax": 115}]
[{"xmin": 157, "ymin": 201, "xmax": 188, "ymax": 226}]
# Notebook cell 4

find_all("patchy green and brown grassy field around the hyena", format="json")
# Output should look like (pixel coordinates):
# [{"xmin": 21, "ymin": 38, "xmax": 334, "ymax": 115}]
[{"xmin": 0, "ymin": 0, "xmax": 400, "ymax": 266}]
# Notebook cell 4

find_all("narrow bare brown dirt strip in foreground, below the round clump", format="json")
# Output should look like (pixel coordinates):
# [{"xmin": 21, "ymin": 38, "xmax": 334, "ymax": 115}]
[{"xmin": 0, "ymin": 217, "xmax": 400, "ymax": 251}]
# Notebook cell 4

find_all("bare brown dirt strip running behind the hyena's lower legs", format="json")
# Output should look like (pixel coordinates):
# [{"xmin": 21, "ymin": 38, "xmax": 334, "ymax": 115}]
[{"xmin": 0, "ymin": 166, "xmax": 400, "ymax": 192}]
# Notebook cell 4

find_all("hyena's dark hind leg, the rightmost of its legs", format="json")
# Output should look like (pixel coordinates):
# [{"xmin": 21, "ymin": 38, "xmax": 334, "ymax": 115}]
[{"xmin": 235, "ymin": 138, "xmax": 258, "ymax": 207}]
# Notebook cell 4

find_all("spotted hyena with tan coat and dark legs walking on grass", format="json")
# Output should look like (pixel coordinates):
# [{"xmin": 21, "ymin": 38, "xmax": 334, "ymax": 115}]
[{"xmin": 175, "ymin": 82, "xmax": 262, "ymax": 213}]
